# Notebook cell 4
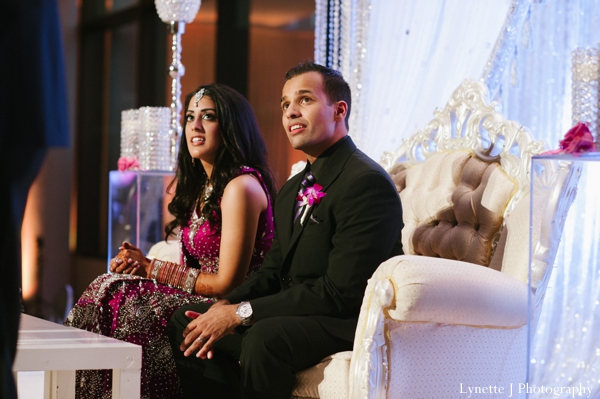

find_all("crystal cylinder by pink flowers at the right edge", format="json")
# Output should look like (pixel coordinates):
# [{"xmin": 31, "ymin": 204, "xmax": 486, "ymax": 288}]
[{"xmin": 571, "ymin": 47, "xmax": 600, "ymax": 142}]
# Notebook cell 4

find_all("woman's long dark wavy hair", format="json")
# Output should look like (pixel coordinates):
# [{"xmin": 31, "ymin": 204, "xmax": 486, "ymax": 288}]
[{"xmin": 165, "ymin": 83, "xmax": 275, "ymax": 238}]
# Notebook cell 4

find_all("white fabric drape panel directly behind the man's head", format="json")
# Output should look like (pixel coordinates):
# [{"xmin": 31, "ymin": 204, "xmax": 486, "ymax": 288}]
[{"xmin": 316, "ymin": 0, "xmax": 511, "ymax": 160}]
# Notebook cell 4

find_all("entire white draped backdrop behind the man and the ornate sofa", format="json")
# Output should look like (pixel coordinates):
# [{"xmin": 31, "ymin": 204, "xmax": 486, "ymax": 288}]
[{"xmin": 315, "ymin": 0, "xmax": 600, "ymax": 397}]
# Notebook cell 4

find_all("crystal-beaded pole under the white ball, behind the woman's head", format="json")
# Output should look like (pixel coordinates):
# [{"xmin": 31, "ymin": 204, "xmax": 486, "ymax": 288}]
[{"xmin": 169, "ymin": 21, "xmax": 185, "ymax": 171}]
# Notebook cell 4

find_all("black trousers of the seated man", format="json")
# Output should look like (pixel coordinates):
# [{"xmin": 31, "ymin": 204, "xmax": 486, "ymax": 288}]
[{"xmin": 168, "ymin": 304, "xmax": 352, "ymax": 399}]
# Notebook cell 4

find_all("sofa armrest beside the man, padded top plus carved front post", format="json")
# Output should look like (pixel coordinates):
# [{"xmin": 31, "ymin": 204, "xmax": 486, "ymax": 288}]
[{"xmin": 349, "ymin": 255, "xmax": 528, "ymax": 398}]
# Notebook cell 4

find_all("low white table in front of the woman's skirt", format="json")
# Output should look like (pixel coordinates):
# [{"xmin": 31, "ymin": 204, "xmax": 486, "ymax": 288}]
[{"xmin": 13, "ymin": 314, "xmax": 142, "ymax": 399}]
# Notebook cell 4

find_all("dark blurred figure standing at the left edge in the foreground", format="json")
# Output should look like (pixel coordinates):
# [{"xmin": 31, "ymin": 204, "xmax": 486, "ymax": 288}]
[{"xmin": 0, "ymin": 0, "xmax": 69, "ymax": 399}]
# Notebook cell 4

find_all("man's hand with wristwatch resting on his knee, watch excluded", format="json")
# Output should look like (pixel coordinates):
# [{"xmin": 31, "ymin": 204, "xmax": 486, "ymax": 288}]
[{"xmin": 179, "ymin": 300, "xmax": 241, "ymax": 359}]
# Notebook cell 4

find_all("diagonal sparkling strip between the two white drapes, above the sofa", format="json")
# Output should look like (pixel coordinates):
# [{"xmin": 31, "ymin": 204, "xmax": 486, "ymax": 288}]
[{"xmin": 481, "ymin": 0, "xmax": 531, "ymax": 100}]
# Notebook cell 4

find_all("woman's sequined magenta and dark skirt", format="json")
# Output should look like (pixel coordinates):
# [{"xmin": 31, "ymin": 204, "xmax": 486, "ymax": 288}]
[{"xmin": 64, "ymin": 274, "xmax": 213, "ymax": 399}]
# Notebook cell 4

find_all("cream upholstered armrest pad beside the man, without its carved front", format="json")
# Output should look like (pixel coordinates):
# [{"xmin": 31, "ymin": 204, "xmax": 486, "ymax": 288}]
[{"xmin": 372, "ymin": 255, "xmax": 528, "ymax": 328}]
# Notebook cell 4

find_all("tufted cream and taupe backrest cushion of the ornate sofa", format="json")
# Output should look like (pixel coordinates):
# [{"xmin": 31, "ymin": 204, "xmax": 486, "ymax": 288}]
[{"xmin": 390, "ymin": 151, "xmax": 517, "ymax": 266}]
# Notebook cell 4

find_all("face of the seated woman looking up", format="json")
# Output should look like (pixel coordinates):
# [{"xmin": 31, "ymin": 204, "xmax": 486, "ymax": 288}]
[{"xmin": 185, "ymin": 95, "xmax": 221, "ymax": 165}]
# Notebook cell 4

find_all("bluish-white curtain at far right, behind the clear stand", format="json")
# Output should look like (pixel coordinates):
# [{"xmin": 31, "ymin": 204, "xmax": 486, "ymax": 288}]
[{"xmin": 502, "ymin": 0, "xmax": 600, "ymax": 398}]
